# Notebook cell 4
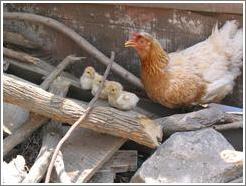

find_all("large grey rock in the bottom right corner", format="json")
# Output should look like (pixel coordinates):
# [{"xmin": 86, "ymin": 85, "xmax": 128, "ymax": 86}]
[{"xmin": 131, "ymin": 128, "xmax": 243, "ymax": 183}]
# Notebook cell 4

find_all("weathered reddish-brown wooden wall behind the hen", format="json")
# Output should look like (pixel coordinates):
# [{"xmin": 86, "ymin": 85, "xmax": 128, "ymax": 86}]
[{"xmin": 4, "ymin": 3, "xmax": 243, "ymax": 107}]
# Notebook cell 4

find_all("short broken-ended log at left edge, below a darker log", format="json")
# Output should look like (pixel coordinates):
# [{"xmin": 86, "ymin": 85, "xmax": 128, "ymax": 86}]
[{"xmin": 3, "ymin": 47, "xmax": 39, "ymax": 64}]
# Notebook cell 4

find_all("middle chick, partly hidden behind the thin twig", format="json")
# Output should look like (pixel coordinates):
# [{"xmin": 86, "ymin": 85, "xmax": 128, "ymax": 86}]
[{"xmin": 91, "ymin": 74, "xmax": 108, "ymax": 99}]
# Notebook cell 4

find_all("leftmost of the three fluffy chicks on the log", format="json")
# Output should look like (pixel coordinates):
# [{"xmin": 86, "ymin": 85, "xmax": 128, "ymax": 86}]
[{"xmin": 80, "ymin": 66, "xmax": 96, "ymax": 90}]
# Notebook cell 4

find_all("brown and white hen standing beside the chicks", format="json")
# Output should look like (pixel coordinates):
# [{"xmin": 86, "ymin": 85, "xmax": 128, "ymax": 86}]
[{"xmin": 125, "ymin": 20, "xmax": 243, "ymax": 108}]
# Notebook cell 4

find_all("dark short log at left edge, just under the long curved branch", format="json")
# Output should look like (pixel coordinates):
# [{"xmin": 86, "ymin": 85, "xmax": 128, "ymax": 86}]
[{"xmin": 3, "ymin": 31, "xmax": 40, "ymax": 49}]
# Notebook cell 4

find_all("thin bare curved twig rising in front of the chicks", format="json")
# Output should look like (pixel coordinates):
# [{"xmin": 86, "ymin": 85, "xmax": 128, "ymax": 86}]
[{"xmin": 45, "ymin": 52, "xmax": 115, "ymax": 183}]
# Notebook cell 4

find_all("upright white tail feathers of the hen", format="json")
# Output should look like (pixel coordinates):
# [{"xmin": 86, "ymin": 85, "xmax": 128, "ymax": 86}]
[{"xmin": 209, "ymin": 20, "xmax": 243, "ymax": 78}]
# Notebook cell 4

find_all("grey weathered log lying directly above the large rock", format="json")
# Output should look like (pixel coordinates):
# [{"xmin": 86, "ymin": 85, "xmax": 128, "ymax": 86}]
[{"xmin": 155, "ymin": 107, "xmax": 242, "ymax": 135}]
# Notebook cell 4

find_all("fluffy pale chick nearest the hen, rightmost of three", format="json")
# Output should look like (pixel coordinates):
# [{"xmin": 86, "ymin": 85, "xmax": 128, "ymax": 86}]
[{"xmin": 106, "ymin": 81, "xmax": 139, "ymax": 110}]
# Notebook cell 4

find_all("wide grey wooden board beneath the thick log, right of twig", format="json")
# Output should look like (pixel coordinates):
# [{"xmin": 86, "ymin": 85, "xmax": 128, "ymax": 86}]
[{"xmin": 51, "ymin": 128, "xmax": 126, "ymax": 183}]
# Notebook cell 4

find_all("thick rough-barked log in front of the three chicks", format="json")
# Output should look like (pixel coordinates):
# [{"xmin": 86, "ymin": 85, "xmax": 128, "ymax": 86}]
[{"xmin": 3, "ymin": 75, "xmax": 162, "ymax": 148}]
